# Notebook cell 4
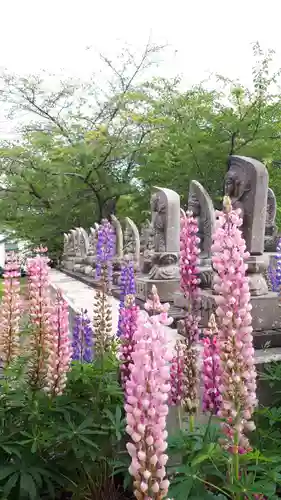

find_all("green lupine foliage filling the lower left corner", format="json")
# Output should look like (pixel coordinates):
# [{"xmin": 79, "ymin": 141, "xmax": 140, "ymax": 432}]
[{"xmin": 0, "ymin": 357, "xmax": 124, "ymax": 500}]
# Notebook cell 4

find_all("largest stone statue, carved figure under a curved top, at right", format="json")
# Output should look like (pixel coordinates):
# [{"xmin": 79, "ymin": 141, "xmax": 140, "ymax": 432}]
[{"xmin": 224, "ymin": 156, "xmax": 268, "ymax": 255}]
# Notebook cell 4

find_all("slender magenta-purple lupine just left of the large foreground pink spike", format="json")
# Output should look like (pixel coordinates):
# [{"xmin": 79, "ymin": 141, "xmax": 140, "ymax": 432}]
[{"xmin": 119, "ymin": 295, "xmax": 139, "ymax": 390}]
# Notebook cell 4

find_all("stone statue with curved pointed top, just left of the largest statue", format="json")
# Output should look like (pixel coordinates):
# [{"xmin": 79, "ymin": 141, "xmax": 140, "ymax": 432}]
[{"xmin": 188, "ymin": 181, "xmax": 216, "ymax": 259}]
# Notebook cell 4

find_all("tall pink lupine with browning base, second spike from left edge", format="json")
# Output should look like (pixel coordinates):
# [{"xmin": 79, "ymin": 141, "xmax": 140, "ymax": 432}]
[{"xmin": 27, "ymin": 255, "xmax": 51, "ymax": 388}]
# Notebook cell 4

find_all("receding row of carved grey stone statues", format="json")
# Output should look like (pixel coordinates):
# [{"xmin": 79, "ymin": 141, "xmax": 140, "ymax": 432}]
[{"xmin": 60, "ymin": 156, "xmax": 277, "ymax": 287}]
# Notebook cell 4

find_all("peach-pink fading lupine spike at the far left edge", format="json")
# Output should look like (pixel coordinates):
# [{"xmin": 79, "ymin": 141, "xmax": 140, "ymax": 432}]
[{"xmin": 0, "ymin": 253, "xmax": 21, "ymax": 368}]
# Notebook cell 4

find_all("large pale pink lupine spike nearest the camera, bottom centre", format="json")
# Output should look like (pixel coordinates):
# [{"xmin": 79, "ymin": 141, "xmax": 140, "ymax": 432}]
[{"xmin": 125, "ymin": 290, "xmax": 171, "ymax": 500}]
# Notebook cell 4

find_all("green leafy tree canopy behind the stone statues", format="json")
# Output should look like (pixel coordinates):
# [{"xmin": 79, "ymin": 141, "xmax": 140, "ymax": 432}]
[{"xmin": 0, "ymin": 44, "xmax": 281, "ymax": 253}]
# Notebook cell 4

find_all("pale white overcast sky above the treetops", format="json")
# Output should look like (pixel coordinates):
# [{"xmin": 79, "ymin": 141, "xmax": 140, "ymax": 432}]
[{"xmin": 0, "ymin": 0, "xmax": 281, "ymax": 135}]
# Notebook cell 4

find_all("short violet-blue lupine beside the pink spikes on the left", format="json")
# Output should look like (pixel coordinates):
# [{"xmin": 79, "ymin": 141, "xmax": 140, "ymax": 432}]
[{"xmin": 72, "ymin": 309, "xmax": 94, "ymax": 363}]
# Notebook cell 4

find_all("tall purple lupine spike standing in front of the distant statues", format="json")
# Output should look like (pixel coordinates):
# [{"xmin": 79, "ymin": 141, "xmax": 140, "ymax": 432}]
[{"xmin": 96, "ymin": 219, "xmax": 116, "ymax": 284}]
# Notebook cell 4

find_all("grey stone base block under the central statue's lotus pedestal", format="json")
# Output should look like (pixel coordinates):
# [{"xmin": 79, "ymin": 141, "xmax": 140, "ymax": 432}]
[{"xmin": 136, "ymin": 276, "xmax": 179, "ymax": 302}]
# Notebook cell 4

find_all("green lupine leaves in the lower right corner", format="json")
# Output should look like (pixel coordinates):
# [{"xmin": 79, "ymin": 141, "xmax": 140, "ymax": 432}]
[{"xmin": 168, "ymin": 422, "xmax": 281, "ymax": 500}]
